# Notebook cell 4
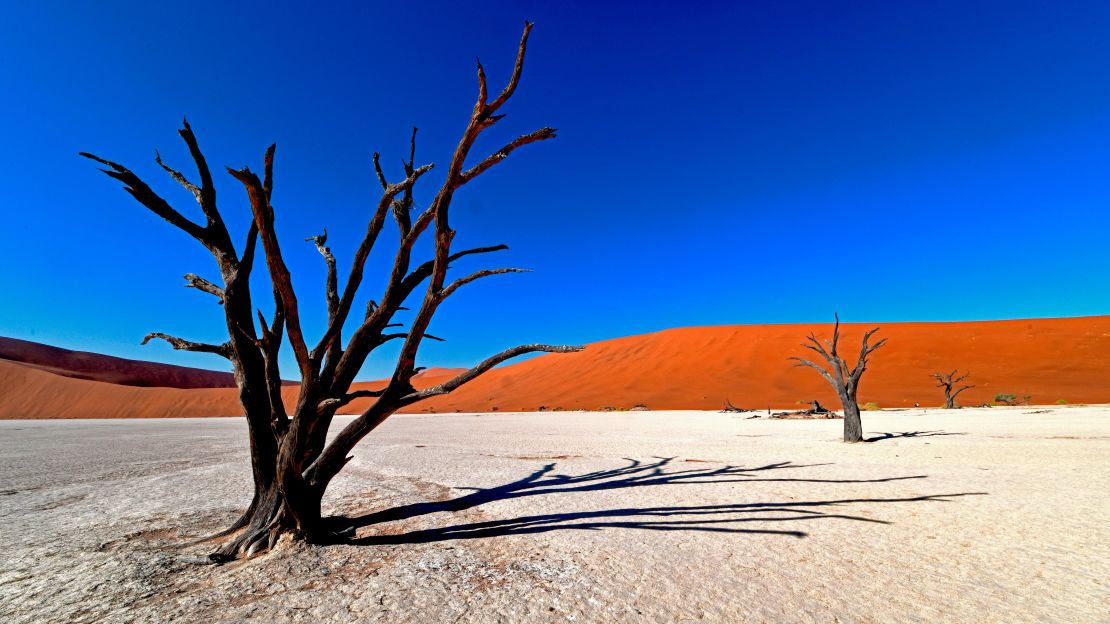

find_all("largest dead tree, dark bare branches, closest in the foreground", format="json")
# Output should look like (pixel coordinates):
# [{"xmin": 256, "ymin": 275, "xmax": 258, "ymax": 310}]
[{"xmin": 81, "ymin": 23, "xmax": 581, "ymax": 558}]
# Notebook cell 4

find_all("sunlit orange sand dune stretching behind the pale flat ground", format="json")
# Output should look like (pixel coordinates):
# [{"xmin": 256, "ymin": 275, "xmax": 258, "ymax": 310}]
[{"xmin": 0, "ymin": 316, "xmax": 1110, "ymax": 419}]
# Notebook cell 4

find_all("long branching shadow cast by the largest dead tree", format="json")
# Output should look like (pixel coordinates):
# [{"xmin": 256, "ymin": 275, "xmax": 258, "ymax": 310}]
[{"xmin": 325, "ymin": 457, "xmax": 985, "ymax": 545}]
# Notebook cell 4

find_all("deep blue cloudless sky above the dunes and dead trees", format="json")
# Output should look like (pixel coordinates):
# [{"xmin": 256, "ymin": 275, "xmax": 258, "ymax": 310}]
[{"xmin": 0, "ymin": 1, "xmax": 1110, "ymax": 378}]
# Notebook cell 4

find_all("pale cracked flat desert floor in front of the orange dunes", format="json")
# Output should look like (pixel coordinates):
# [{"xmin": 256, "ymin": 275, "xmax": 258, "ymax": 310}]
[{"xmin": 0, "ymin": 407, "xmax": 1110, "ymax": 623}]
